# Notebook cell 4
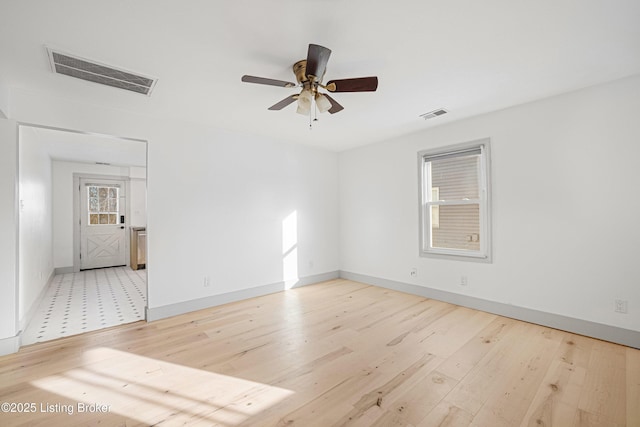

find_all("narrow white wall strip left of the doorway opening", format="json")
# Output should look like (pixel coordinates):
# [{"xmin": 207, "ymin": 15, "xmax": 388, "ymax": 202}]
[{"xmin": 0, "ymin": 118, "xmax": 18, "ymax": 355}]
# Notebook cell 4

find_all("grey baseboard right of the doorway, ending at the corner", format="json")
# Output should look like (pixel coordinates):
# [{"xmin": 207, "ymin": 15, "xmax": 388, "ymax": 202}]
[{"xmin": 146, "ymin": 270, "xmax": 340, "ymax": 322}]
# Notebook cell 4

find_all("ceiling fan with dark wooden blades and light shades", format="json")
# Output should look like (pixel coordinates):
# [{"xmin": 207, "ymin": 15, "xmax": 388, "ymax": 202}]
[{"xmin": 242, "ymin": 44, "xmax": 378, "ymax": 117}]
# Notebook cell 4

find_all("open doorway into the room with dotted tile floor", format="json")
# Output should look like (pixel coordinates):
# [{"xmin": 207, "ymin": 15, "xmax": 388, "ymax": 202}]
[{"xmin": 18, "ymin": 124, "xmax": 148, "ymax": 344}]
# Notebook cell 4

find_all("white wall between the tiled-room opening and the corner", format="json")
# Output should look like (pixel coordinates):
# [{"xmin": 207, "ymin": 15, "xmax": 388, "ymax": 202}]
[{"xmin": 11, "ymin": 91, "xmax": 339, "ymax": 308}]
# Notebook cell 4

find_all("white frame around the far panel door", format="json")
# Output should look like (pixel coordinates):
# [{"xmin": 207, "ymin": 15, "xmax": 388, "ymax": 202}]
[{"xmin": 73, "ymin": 172, "xmax": 131, "ymax": 273}]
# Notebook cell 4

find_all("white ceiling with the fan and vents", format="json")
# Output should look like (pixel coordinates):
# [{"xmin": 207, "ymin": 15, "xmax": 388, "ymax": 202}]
[{"xmin": 0, "ymin": 0, "xmax": 640, "ymax": 151}]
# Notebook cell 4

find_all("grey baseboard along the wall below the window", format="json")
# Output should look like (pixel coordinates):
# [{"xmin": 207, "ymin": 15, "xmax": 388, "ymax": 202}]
[{"xmin": 340, "ymin": 271, "xmax": 640, "ymax": 349}]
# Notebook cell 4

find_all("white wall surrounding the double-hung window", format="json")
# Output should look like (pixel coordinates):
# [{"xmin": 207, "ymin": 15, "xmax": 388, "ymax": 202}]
[{"xmin": 339, "ymin": 76, "xmax": 640, "ymax": 331}]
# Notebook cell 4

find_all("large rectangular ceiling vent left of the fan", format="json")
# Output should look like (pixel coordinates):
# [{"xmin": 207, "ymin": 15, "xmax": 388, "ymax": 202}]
[{"xmin": 47, "ymin": 48, "xmax": 157, "ymax": 96}]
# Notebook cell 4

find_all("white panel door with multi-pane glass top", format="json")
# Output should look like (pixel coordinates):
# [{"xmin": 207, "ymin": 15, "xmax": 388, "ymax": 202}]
[{"xmin": 80, "ymin": 178, "xmax": 127, "ymax": 270}]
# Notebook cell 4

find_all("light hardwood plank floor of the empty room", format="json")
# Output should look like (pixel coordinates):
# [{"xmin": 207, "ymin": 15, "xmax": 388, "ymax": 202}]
[{"xmin": 0, "ymin": 280, "xmax": 640, "ymax": 427}]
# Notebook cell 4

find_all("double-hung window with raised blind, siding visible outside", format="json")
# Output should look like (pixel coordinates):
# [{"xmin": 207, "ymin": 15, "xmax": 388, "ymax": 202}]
[{"xmin": 418, "ymin": 140, "xmax": 491, "ymax": 262}]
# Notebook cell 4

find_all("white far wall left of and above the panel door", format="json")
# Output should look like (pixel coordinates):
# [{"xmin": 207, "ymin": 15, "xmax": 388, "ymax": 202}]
[{"xmin": 52, "ymin": 160, "xmax": 137, "ymax": 268}]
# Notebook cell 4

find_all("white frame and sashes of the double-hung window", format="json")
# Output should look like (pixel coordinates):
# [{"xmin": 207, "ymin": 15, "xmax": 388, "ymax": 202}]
[{"xmin": 418, "ymin": 138, "xmax": 493, "ymax": 263}]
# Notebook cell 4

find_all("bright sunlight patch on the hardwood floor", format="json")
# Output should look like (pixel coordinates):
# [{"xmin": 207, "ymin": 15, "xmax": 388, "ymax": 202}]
[{"xmin": 31, "ymin": 347, "xmax": 293, "ymax": 425}]
